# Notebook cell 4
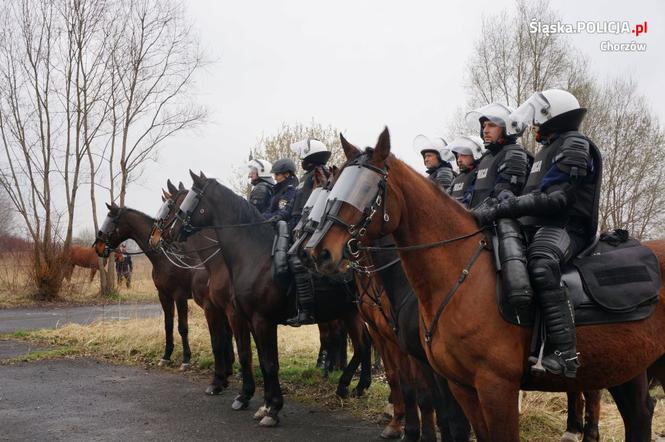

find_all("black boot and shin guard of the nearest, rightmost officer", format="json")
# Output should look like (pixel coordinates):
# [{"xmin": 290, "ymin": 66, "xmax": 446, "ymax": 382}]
[{"xmin": 540, "ymin": 288, "xmax": 580, "ymax": 378}]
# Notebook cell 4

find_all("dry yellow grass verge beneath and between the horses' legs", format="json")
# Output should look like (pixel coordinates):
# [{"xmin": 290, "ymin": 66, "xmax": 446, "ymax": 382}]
[{"xmin": 6, "ymin": 306, "xmax": 665, "ymax": 441}]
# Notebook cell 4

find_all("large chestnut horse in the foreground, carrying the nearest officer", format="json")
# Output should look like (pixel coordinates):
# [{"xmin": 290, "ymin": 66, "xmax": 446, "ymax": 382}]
[{"xmin": 308, "ymin": 129, "xmax": 665, "ymax": 442}]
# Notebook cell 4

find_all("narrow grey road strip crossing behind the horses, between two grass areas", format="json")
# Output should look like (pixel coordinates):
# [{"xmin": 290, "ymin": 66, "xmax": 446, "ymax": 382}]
[{"xmin": 0, "ymin": 304, "xmax": 162, "ymax": 334}]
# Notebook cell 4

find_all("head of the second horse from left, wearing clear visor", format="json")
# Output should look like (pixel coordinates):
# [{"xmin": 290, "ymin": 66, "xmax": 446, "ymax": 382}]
[{"xmin": 150, "ymin": 170, "xmax": 215, "ymax": 247}]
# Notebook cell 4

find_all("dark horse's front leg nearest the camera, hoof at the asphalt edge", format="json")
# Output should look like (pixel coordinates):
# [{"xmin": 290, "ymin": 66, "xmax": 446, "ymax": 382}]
[{"xmin": 252, "ymin": 315, "xmax": 284, "ymax": 427}]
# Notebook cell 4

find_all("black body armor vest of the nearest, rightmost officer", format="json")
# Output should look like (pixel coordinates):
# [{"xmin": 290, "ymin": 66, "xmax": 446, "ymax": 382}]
[{"xmin": 520, "ymin": 132, "xmax": 602, "ymax": 238}]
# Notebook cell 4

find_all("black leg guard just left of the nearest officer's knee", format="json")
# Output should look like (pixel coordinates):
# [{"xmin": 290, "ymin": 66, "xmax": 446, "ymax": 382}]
[{"xmin": 497, "ymin": 218, "xmax": 533, "ymax": 308}]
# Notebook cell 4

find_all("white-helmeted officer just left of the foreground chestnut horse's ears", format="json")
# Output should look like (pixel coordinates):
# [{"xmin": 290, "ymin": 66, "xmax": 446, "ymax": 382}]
[{"xmin": 286, "ymin": 138, "xmax": 332, "ymax": 327}]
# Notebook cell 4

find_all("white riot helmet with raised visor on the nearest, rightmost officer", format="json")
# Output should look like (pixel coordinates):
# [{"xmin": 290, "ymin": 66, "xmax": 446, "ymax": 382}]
[{"xmin": 508, "ymin": 89, "xmax": 586, "ymax": 135}]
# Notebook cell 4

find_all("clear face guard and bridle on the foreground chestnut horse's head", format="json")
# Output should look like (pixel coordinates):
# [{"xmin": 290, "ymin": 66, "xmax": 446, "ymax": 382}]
[{"xmin": 305, "ymin": 155, "xmax": 390, "ymax": 259}]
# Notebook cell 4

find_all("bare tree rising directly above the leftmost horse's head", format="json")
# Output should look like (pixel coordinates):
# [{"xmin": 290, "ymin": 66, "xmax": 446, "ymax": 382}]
[{"xmin": 103, "ymin": 0, "xmax": 206, "ymax": 206}]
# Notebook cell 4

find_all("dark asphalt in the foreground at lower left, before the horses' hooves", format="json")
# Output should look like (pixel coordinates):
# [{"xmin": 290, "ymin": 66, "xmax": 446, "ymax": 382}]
[{"xmin": 0, "ymin": 352, "xmax": 381, "ymax": 442}]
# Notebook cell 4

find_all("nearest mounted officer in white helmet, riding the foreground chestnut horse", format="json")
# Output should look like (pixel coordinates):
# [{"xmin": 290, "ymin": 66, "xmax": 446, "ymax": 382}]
[{"xmin": 474, "ymin": 89, "xmax": 602, "ymax": 378}]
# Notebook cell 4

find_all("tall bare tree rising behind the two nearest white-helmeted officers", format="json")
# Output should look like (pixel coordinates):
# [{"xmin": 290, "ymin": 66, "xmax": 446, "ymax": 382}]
[{"xmin": 464, "ymin": 0, "xmax": 590, "ymax": 151}]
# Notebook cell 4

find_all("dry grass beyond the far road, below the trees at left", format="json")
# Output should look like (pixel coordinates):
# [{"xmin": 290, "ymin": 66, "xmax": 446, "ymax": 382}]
[{"xmin": 0, "ymin": 253, "xmax": 157, "ymax": 308}]
